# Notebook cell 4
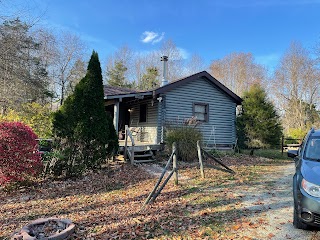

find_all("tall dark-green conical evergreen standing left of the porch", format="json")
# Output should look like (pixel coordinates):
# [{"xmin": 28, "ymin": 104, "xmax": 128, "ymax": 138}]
[{"xmin": 53, "ymin": 51, "xmax": 118, "ymax": 176}]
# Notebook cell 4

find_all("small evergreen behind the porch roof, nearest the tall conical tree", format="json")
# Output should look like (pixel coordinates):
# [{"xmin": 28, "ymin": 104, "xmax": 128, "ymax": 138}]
[{"xmin": 107, "ymin": 61, "xmax": 132, "ymax": 88}]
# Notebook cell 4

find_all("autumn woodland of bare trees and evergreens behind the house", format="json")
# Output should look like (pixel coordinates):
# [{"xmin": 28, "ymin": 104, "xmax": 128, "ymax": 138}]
[{"xmin": 0, "ymin": 1, "xmax": 320, "ymax": 140}]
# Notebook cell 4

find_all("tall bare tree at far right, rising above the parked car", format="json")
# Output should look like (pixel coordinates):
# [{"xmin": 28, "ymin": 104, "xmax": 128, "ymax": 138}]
[{"xmin": 272, "ymin": 42, "xmax": 320, "ymax": 131}]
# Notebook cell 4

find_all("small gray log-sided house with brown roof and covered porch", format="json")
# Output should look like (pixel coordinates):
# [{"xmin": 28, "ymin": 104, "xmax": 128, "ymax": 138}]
[{"xmin": 104, "ymin": 71, "xmax": 242, "ymax": 149}]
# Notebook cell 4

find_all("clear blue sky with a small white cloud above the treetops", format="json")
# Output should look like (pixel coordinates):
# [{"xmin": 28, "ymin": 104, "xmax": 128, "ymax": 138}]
[{"xmin": 4, "ymin": 0, "xmax": 320, "ymax": 69}]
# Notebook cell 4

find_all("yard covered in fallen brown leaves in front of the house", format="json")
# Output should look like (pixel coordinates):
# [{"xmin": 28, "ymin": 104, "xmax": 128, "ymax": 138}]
[{"xmin": 0, "ymin": 155, "xmax": 318, "ymax": 239}]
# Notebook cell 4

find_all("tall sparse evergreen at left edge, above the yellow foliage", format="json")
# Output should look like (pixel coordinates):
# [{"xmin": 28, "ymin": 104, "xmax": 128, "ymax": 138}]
[{"xmin": 0, "ymin": 19, "xmax": 49, "ymax": 110}]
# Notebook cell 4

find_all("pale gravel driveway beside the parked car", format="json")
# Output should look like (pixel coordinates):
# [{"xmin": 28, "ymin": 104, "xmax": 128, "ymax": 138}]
[{"xmin": 235, "ymin": 163, "xmax": 320, "ymax": 239}]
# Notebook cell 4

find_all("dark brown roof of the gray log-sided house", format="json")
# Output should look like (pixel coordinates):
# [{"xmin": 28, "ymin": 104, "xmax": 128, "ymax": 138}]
[{"xmin": 104, "ymin": 71, "xmax": 242, "ymax": 104}]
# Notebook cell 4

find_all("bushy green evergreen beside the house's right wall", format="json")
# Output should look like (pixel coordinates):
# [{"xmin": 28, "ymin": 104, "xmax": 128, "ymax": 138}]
[{"xmin": 237, "ymin": 84, "xmax": 282, "ymax": 148}]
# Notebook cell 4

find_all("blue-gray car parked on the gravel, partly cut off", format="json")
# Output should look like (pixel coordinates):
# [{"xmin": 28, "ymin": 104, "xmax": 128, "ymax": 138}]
[{"xmin": 288, "ymin": 128, "xmax": 320, "ymax": 229}]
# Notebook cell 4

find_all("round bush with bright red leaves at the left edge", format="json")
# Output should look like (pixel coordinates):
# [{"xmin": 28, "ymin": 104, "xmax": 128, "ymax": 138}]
[{"xmin": 0, "ymin": 122, "xmax": 42, "ymax": 185}]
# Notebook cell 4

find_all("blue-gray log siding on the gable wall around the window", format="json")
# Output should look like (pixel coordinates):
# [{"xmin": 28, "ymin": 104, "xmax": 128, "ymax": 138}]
[{"xmin": 165, "ymin": 78, "xmax": 236, "ymax": 146}]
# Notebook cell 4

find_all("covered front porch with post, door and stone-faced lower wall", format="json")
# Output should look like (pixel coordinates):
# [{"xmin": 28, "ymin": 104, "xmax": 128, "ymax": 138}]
[{"xmin": 105, "ymin": 87, "xmax": 161, "ymax": 146}]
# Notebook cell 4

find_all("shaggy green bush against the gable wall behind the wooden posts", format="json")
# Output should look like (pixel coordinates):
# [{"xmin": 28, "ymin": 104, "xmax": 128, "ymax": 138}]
[{"xmin": 166, "ymin": 126, "xmax": 202, "ymax": 162}]
